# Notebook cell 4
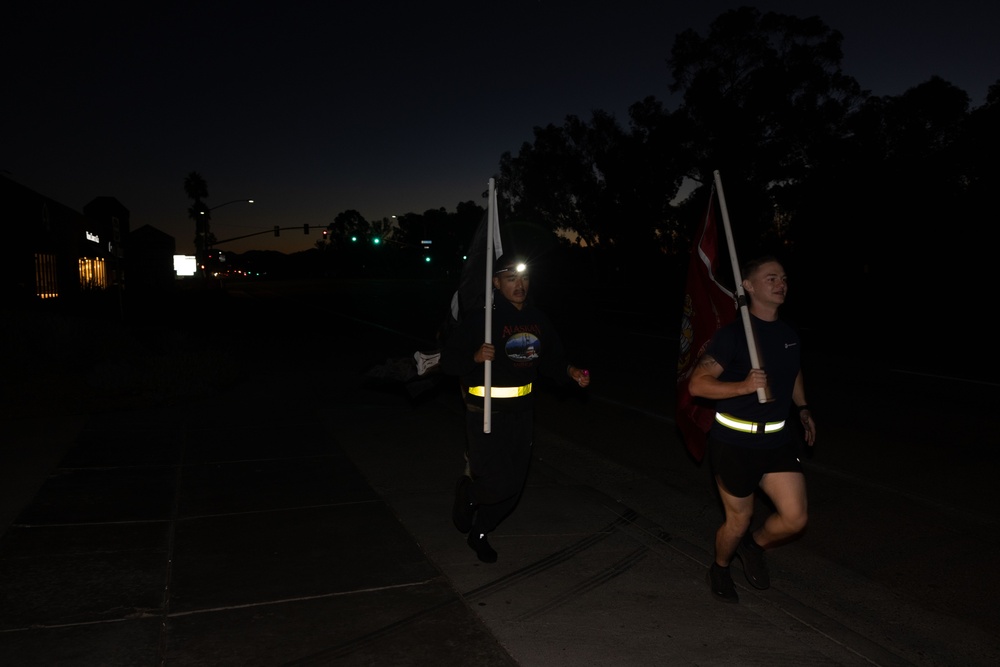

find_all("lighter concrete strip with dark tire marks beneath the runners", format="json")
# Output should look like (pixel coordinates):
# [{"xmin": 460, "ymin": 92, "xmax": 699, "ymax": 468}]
[{"xmin": 326, "ymin": 398, "xmax": 908, "ymax": 667}]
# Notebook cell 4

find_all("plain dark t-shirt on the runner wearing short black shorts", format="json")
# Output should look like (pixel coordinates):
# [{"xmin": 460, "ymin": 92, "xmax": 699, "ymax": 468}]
[{"xmin": 706, "ymin": 315, "xmax": 801, "ymax": 447}]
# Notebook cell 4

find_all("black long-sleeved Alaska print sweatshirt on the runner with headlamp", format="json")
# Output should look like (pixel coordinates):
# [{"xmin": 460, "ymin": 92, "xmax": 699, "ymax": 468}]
[{"xmin": 440, "ymin": 295, "xmax": 566, "ymax": 409}]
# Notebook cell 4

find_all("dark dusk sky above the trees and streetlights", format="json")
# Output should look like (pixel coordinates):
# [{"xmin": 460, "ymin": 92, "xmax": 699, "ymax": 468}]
[{"xmin": 0, "ymin": 0, "xmax": 1000, "ymax": 253}]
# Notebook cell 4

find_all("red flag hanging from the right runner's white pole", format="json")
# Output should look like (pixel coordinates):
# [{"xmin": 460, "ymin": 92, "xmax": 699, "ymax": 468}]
[{"xmin": 676, "ymin": 187, "xmax": 736, "ymax": 462}]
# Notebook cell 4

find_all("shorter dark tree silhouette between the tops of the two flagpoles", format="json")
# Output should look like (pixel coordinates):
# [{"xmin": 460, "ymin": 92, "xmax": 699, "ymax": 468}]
[{"xmin": 499, "ymin": 97, "xmax": 684, "ymax": 281}]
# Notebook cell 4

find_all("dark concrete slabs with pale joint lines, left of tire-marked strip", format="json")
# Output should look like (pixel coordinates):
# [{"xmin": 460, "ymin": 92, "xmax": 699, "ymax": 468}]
[{"xmin": 0, "ymin": 378, "xmax": 514, "ymax": 667}]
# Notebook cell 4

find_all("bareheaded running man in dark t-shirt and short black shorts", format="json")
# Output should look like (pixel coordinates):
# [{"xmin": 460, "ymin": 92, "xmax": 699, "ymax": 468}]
[{"xmin": 688, "ymin": 256, "xmax": 816, "ymax": 602}]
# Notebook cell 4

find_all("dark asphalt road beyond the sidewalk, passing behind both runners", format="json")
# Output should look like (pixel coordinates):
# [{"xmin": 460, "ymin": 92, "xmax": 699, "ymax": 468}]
[{"xmin": 209, "ymin": 281, "xmax": 1000, "ymax": 665}]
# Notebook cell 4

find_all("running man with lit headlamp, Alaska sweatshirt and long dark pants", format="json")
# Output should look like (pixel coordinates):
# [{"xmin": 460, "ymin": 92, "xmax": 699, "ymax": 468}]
[{"xmin": 440, "ymin": 255, "xmax": 590, "ymax": 563}]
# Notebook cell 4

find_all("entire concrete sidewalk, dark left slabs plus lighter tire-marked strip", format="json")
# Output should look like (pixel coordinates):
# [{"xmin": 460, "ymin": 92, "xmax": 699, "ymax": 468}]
[{"xmin": 0, "ymin": 366, "xmax": 907, "ymax": 667}]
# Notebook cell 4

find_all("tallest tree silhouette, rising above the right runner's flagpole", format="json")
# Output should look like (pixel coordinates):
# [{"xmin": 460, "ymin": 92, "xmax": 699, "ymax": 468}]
[{"xmin": 669, "ymin": 7, "xmax": 865, "ymax": 252}]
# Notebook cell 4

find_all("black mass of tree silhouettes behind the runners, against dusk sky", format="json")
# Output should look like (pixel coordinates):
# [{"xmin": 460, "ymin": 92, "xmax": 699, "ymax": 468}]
[{"xmin": 306, "ymin": 7, "xmax": 1000, "ymax": 344}]
